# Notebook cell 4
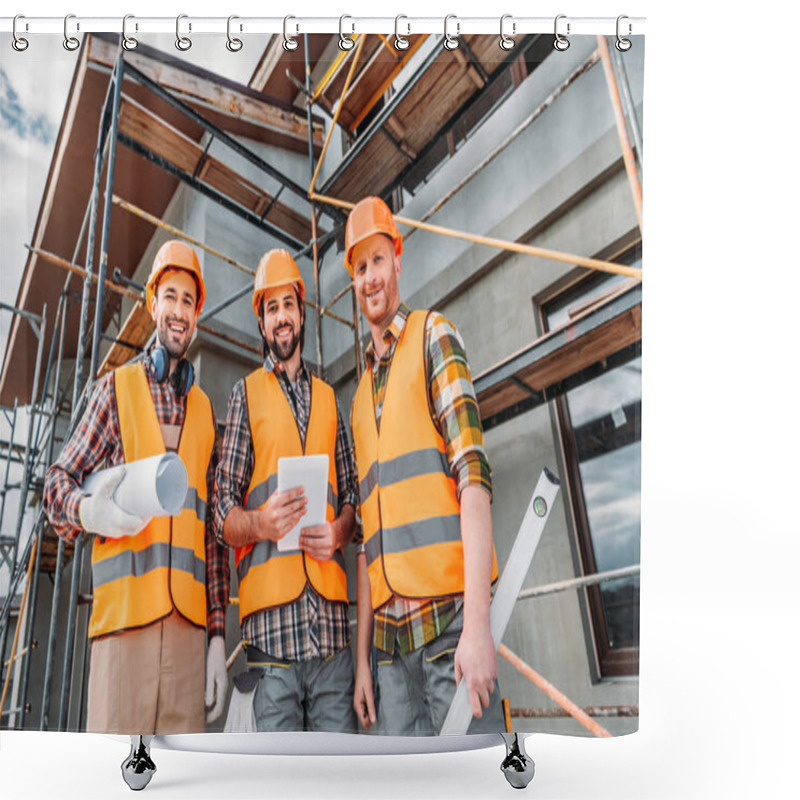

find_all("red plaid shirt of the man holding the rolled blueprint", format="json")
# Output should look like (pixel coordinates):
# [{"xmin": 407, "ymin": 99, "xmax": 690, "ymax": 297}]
[{"xmin": 44, "ymin": 354, "xmax": 230, "ymax": 638}]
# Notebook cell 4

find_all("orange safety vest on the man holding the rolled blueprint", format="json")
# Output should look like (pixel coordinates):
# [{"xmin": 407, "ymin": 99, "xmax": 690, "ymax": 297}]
[{"xmin": 89, "ymin": 363, "xmax": 216, "ymax": 639}]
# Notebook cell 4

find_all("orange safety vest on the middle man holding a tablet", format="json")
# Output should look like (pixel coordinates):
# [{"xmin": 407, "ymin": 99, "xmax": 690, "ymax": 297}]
[{"xmin": 236, "ymin": 367, "xmax": 347, "ymax": 622}]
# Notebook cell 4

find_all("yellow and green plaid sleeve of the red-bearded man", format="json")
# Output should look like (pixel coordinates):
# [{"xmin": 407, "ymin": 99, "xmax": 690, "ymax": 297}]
[{"xmin": 425, "ymin": 312, "xmax": 492, "ymax": 497}]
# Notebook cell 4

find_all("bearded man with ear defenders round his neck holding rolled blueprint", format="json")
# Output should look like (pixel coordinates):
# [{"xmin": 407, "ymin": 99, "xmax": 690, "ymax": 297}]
[{"xmin": 44, "ymin": 241, "xmax": 230, "ymax": 735}]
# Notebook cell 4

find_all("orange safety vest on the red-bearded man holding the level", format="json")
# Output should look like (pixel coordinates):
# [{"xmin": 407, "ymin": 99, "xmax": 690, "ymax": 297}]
[{"xmin": 353, "ymin": 311, "xmax": 497, "ymax": 609}]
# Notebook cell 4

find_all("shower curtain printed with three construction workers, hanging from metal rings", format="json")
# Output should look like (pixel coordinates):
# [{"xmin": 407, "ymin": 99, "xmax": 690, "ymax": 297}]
[{"xmin": 0, "ymin": 18, "xmax": 645, "ymax": 737}]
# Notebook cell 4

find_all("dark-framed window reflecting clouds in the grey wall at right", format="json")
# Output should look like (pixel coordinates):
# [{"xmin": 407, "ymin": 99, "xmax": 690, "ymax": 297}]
[{"xmin": 540, "ymin": 246, "xmax": 642, "ymax": 676}]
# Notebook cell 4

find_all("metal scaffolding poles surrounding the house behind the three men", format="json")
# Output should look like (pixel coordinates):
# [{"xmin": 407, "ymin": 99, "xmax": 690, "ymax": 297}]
[{"xmin": 0, "ymin": 29, "xmax": 642, "ymax": 736}]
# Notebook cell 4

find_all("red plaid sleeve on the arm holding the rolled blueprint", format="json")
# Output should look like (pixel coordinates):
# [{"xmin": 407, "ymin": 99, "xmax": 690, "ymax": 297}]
[{"xmin": 44, "ymin": 373, "xmax": 123, "ymax": 542}]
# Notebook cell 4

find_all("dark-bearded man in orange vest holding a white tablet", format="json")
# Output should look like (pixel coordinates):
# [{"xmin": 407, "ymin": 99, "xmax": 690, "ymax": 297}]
[{"xmin": 216, "ymin": 250, "xmax": 357, "ymax": 733}]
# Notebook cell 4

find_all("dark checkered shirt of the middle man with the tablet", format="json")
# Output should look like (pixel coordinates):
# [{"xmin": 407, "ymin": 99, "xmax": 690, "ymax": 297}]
[{"xmin": 215, "ymin": 355, "xmax": 358, "ymax": 661}]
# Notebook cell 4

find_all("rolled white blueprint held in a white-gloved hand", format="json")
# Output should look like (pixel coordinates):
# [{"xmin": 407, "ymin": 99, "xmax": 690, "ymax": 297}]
[{"xmin": 81, "ymin": 453, "xmax": 189, "ymax": 518}]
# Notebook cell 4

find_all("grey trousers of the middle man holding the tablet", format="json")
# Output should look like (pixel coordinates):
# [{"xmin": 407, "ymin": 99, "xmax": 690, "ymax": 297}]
[{"xmin": 253, "ymin": 647, "xmax": 358, "ymax": 733}]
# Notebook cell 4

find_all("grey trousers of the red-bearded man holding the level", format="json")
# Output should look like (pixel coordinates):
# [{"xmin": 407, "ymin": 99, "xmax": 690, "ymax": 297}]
[{"xmin": 376, "ymin": 610, "xmax": 506, "ymax": 736}]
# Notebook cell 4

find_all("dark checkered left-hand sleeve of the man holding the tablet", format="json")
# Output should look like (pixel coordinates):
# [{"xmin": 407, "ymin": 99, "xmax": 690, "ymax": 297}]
[{"xmin": 214, "ymin": 380, "xmax": 255, "ymax": 544}]
